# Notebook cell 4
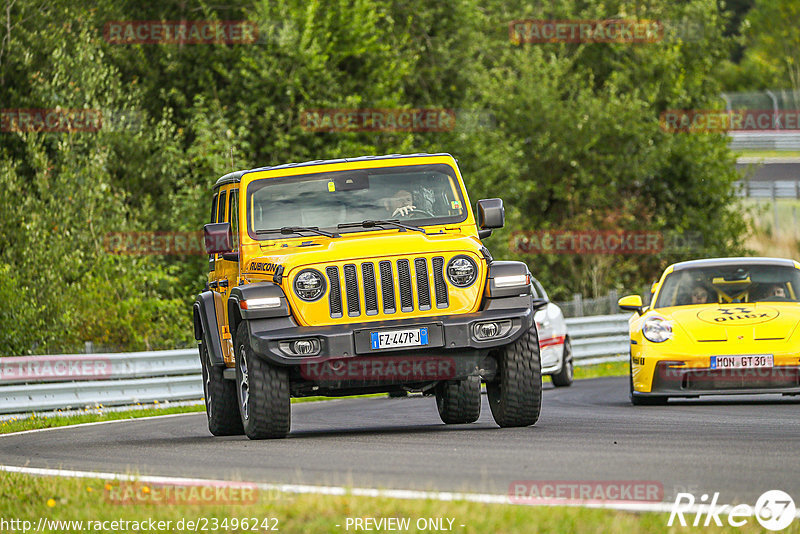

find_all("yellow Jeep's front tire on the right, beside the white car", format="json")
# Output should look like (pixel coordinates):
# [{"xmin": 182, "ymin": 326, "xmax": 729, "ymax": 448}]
[{"xmin": 486, "ymin": 327, "xmax": 542, "ymax": 428}]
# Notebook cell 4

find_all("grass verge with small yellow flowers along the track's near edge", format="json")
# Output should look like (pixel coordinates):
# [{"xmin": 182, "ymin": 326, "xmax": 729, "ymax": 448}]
[{"xmin": 0, "ymin": 473, "xmax": 780, "ymax": 534}]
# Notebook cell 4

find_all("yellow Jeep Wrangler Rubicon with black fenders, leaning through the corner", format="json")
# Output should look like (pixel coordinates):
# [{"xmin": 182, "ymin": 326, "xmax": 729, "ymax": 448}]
[{"xmin": 193, "ymin": 154, "xmax": 543, "ymax": 439}]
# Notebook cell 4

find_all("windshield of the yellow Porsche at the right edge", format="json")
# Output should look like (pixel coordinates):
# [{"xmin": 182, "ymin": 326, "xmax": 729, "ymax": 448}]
[{"xmin": 655, "ymin": 264, "xmax": 800, "ymax": 308}]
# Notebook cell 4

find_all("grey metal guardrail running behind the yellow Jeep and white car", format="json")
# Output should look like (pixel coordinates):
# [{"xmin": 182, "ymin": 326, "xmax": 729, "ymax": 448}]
[{"xmin": 0, "ymin": 314, "xmax": 630, "ymax": 414}]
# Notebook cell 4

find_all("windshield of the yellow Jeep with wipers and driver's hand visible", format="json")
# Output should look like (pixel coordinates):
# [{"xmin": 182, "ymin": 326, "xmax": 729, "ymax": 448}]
[{"xmin": 247, "ymin": 164, "xmax": 467, "ymax": 239}]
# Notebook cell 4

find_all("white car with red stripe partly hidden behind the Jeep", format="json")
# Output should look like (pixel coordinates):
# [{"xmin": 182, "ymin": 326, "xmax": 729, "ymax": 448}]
[{"xmin": 531, "ymin": 276, "xmax": 573, "ymax": 387}]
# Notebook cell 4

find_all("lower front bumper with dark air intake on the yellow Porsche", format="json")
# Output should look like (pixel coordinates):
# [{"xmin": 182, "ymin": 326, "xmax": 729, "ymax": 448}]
[{"xmin": 634, "ymin": 361, "xmax": 800, "ymax": 397}]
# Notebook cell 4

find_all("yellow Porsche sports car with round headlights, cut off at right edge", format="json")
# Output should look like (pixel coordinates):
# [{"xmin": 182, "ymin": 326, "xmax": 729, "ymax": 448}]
[{"xmin": 619, "ymin": 258, "xmax": 800, "ymax": 405}]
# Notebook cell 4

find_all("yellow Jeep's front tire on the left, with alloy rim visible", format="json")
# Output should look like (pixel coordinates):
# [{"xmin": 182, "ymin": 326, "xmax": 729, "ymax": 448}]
[{"xmin": 235, "ymin": 322, "xmax": 291, "ymax": 439}]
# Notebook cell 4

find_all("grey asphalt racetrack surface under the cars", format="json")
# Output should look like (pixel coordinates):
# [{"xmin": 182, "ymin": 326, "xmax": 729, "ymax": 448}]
[{"xmin": 0, "ymin": 377, "xmax": 800, "ymax": 503}]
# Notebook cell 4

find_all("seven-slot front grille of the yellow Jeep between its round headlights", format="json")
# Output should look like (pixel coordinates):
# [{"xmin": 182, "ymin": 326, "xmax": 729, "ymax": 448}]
[{"xmin": 325, "ymin": 256, "xmax": 448, "ymax": 318}]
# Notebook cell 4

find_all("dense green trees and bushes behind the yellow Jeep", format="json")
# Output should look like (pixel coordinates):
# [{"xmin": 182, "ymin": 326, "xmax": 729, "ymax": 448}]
[{"xmin": 0, "ymin": 0, "xmax": 756, "ymax": 354}]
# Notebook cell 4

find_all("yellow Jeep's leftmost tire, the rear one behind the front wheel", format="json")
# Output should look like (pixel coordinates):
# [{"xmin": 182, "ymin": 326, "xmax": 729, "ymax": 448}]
[{"xmin": 198, "ymin": 343, "xmax": 244, "ymax": 436}]
